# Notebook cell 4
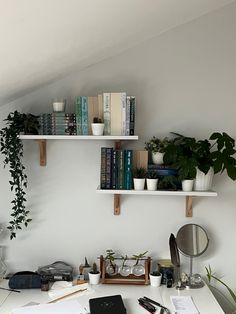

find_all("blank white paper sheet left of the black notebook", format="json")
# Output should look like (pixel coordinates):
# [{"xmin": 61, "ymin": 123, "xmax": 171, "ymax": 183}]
[{"xmin": 12, "ymin": 300, "xmax": 88, "ymax": 314}]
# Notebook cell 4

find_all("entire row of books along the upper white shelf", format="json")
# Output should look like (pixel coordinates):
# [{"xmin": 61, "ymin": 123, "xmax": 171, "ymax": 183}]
[{"xmin": 39, "ymin": 92, "xmax": 136, "ymax": 136}]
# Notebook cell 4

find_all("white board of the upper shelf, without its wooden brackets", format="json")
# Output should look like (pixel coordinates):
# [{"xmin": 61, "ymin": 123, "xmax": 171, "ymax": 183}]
[{"xmin": 20, "ymin": 135, "xmax": 138, "ymax": 141}]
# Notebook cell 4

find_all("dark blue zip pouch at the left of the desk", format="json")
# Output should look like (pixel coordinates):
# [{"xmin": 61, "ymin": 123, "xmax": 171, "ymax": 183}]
[{"xmin": 8, "ymin": 271, "xmax": 41, "ymax": 289}]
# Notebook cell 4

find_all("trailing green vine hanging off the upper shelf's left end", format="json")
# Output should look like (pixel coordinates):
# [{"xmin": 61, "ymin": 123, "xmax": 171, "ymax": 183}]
[{"xmin": 0, "ymin": 111, "xmax": 39, "ymax": 239}]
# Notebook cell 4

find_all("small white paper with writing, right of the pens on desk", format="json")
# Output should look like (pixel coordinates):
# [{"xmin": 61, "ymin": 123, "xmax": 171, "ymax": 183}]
[{"xmin": 170, "ymin": 296, "xmax": 199, "ymax": 314}]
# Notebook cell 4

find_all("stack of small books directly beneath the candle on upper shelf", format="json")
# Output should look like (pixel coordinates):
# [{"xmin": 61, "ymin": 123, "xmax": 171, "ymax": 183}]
[{"xmin": 51, "ymin": 112, "xmax": 76, "ymax": 135}]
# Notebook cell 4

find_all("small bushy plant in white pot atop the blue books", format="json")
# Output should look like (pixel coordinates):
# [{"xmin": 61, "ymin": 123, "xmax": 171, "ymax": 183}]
[{"xmin": 145, "ymin": 136, "xmax": 170, "ymax": 165}]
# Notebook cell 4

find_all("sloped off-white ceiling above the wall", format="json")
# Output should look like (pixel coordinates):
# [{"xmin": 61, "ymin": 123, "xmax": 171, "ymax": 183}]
[{"xmin": 0, "ymin": 0, "xmax": 233, "ymax": 105}]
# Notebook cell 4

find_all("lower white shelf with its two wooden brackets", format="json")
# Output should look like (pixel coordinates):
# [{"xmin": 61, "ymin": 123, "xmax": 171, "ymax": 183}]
[{"xmin": 96, "ymin": 186, "xmax": 217, "ymax": 217}]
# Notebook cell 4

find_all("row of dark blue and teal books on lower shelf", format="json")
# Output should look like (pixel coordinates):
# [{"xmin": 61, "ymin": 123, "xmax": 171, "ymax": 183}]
[{"xmin": 100, "ymin": 147, "xmax": 133, "ymax": 190}]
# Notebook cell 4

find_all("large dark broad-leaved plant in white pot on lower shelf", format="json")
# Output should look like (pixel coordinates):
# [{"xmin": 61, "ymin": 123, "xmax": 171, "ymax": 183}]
[{"xmin": 164, "ymin": 132, "xmax": 236, "ymax": 191}]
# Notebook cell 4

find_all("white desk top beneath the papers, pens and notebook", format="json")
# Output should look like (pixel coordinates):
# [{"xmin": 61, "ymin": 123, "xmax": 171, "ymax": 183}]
[{"xmin": 0, "ymin": 281, "xmax": 224, "ymax": 314}]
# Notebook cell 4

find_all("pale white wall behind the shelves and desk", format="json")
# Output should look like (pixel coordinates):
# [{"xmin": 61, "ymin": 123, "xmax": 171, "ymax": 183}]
[{"xmin": 0, "ymin": 4, "xmax": 236, "ymax": 312}]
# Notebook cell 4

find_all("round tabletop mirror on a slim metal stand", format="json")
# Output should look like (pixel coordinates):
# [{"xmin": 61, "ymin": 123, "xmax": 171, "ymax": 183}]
[{"xmin": 176, "ymin": 224, "xmax": 209, "ymax": 288}]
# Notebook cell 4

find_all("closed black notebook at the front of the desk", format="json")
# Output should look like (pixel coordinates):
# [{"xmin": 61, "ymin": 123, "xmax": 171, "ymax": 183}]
[{"xmin": 89, "ymin": 295, "xmax": 126, "ymax": 314}]
